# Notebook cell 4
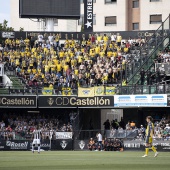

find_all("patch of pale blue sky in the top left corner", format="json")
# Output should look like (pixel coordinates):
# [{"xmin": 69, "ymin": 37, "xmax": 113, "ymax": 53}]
[{"xmin": 0, "ymin": 0, "xmax": 10, "ymax": 26}]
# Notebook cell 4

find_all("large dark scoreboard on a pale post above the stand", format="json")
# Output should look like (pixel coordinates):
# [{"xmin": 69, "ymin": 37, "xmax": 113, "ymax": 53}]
[{"xmin": 19, "ymin": 0, "xmax": 80, "ymax": 19}]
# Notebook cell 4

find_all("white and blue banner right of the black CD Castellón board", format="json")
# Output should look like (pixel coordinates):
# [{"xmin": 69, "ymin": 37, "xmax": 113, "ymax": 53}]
[{"xmin": 114, "ymin": 94, "xmax": 167, "ymax": 107}]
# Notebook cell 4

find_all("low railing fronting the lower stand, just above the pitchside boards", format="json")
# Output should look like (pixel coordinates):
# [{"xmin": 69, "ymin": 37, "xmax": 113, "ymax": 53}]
[{"xmin": 0, "ymin": 129, "xmax": 170, "ymax": 141}]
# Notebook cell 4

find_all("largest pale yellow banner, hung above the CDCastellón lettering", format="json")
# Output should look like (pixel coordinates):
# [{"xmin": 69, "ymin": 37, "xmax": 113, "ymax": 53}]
[{"xmin": 78, "ymin": 87, "xmax": 94, "ymax": 97}]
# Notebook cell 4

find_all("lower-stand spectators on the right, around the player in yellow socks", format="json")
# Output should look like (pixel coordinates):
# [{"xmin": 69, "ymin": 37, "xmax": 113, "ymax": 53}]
[{"xmin": 103, "ymin": 117, "xmax": 170, "ymax": 141}]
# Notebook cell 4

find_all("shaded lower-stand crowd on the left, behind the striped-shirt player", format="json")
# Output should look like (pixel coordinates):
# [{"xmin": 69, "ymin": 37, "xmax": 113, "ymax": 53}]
[{"xmin": 0, "ymin": 113, "xmax": 76, "ymax": 139}]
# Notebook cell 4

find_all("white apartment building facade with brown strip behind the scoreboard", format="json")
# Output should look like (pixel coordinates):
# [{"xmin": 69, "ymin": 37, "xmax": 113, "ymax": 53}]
[{"xmin": 10, "ymin": 0, "xmax": 170, "ymax": 32}]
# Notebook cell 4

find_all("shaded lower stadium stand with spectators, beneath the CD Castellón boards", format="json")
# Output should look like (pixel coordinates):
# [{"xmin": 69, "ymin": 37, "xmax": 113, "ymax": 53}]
[{"xmin": 0, "ymin": 113, "xmax": 170, "ymax": 141}]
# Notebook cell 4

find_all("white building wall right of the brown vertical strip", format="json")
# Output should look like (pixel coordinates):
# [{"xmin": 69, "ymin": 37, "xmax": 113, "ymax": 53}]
[{"xmin": 140, "ymin": 0, "xmax": 170, "ymax": 30}]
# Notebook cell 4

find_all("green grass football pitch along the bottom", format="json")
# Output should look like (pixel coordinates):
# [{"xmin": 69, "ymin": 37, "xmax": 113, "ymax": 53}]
[{"xmin": 0, "ymin": 151, "xmax": 170, "ymax": 170}]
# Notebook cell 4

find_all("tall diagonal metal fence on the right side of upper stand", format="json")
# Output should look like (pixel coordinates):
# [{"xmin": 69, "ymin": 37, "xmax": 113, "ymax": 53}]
[{"xmin": 126, "ymin": 16, "xmax": 170, "ymax": 84}]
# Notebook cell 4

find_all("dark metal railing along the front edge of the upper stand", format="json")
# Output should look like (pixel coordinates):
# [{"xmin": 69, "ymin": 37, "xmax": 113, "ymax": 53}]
[{"xmin": 0, "ymin": 81, "xmax": 170, "ymax": 96}]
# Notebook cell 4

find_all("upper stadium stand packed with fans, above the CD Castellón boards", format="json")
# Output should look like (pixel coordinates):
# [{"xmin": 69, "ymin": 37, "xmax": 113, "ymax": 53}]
[{"xmin": 0, "ymin": 14, "xmax": 170, "ymax": 95}]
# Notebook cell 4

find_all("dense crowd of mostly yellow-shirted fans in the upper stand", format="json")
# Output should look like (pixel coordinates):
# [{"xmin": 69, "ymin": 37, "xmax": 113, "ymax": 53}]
[{"xmin": 0, "ymin": 34, "xmax": 145, "ymax": 89}]
